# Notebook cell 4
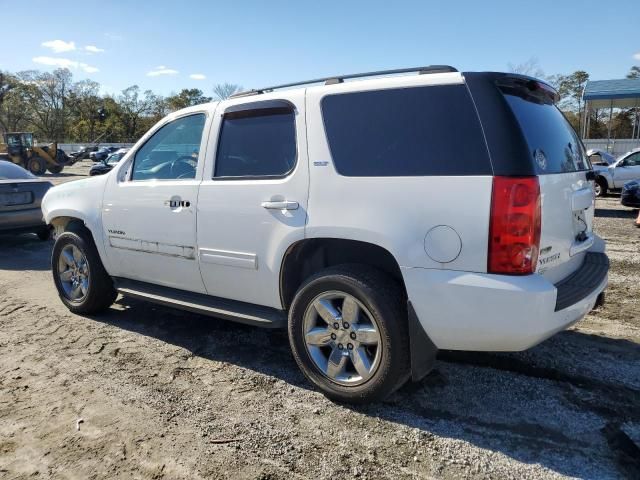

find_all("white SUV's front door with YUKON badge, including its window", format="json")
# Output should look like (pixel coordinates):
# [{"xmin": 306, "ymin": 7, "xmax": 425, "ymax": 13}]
[{"xmin": 102, "ymin": 112, "xmax": 207, "ymax": 293}]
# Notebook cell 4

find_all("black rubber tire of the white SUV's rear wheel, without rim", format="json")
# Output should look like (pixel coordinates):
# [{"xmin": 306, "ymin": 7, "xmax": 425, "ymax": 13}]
[{"xmin": 289, "ymin": 265, "xmax": 410, "ymax": 404}]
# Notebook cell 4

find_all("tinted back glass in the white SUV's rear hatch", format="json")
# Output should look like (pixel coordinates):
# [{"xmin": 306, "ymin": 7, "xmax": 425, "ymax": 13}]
[{"xmin": 504, "ymin": 95, "xmax": 589, "ymax": 174}]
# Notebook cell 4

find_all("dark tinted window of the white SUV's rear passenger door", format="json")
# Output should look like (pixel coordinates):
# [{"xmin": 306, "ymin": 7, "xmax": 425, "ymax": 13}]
[{"xmin": 214, "ymin": 107, "xmax": 296, "ymax": 177}]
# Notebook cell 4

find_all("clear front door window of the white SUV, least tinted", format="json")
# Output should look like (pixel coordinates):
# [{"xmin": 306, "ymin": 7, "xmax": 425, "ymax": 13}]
[{"xmin": 131, "ymin": 113, "xmax": 205, "ymax": 181}]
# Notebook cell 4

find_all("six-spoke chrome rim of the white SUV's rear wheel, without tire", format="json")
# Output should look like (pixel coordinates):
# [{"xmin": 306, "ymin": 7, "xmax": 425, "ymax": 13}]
[{"xmin": 304, "ymin": 291, "xmax": 382, "ymax": 386}]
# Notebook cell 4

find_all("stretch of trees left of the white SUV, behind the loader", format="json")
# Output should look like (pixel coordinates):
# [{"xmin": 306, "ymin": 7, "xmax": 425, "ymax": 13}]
[{"xmin": 0, "ymin": 69, "xmax": 241, "ymax": 143}]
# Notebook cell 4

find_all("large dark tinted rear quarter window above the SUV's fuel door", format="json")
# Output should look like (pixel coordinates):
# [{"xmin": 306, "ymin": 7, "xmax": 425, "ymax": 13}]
[{"xmin": 322, "ymin": 85, "xmax": 492, "ymax": 177}]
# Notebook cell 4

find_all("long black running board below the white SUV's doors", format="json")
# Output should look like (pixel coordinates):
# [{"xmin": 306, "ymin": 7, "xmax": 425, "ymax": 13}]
[{"xmin": 113, "ymin": 278, "xmax": 287, "ymax": 328}]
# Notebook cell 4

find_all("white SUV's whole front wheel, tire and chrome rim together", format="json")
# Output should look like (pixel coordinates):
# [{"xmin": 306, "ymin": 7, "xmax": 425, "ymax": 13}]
[{"xmin": 51, "ymin": 231, "xmax": 117, "ymax": 314}]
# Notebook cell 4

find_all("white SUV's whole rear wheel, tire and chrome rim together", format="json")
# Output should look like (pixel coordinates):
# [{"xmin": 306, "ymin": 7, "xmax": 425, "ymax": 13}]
[{"xmin": 289, "ymin": 265, "xmax": 410, "ymax": 403}]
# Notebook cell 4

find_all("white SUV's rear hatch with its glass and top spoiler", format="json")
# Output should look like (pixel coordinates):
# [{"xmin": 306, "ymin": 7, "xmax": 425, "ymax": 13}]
[{"xmin": 497, "ymin": 76, "xmax": 594, "ymax": 283}]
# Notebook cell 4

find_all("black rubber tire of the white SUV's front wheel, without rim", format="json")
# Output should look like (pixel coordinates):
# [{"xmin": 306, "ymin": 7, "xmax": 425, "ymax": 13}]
[{"xmin": 51, "ymin": 230, "xmax": 117, "ymax": 315}]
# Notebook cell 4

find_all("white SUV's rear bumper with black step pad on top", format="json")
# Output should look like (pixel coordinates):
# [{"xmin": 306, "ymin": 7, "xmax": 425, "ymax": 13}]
[{"xmin": 402, "ymin": 252, "xmax": 609, "ymax": 351}]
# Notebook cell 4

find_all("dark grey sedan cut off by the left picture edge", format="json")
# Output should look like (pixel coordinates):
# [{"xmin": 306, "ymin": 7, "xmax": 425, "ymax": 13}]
[{"xmin": 0, "ymin": 160, "xmax": 53, "ymax": 240}]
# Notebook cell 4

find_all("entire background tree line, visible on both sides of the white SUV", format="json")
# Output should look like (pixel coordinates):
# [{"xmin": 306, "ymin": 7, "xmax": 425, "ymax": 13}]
[{"xmin": 0, "ymin": 64, "xmax": 640, "ymax": 143}]
